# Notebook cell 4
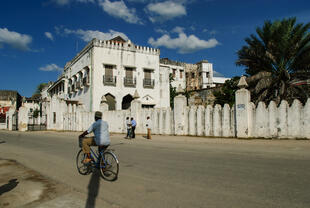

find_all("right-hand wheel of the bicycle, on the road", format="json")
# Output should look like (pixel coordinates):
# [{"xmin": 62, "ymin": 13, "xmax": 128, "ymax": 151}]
[{"xmin": 100, "ymin": 151, "xmax": 119, "ymax": 181}]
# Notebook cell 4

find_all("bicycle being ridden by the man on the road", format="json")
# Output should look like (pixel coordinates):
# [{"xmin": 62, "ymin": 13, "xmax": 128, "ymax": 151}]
[{"xmin": 76, "ymin": 146, "xmax": 119, "ymax": 181}]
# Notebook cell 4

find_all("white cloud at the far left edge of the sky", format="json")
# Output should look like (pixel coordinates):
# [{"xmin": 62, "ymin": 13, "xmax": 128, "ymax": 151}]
[{"xmin": 0, "ymin": 28, "xmax": 32, "ymax": 51}]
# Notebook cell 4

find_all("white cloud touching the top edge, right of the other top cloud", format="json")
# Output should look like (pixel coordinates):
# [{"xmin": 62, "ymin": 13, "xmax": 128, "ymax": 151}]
[{"xmin": 146, "ymin": 1, "xmax": 186, "ymax": 22}]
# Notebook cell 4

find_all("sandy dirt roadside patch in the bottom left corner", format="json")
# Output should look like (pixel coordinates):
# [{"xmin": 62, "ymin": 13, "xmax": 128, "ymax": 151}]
[{"xmin": 0, "ymin": 158, "xmax": 92, "ymax": 208}]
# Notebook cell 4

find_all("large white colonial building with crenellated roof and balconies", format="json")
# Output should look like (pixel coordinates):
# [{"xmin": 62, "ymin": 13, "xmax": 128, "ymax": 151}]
[{"xmin": 47, "ymin": 37, "xmax": 170, "ymax": 127}]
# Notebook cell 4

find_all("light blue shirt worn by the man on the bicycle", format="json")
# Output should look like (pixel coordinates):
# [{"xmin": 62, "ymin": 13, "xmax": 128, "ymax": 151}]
[{"xmin": 87, "ymin": 119, "xmax": 110, "ymax": 145}]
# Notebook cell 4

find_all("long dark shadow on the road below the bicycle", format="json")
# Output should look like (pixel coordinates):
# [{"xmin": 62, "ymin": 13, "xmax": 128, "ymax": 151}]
[{"xmin": 85, "ymin": 168, "xmax": 100, "ymax": 208}]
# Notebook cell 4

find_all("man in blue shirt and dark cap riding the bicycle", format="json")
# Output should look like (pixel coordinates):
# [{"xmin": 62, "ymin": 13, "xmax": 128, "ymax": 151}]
[{"xmin": 79, "ymin": 111, "xmax": 110, "ymax": 163}]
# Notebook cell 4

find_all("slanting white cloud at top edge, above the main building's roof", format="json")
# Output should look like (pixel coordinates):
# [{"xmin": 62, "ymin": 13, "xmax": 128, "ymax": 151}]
[{"xmin": 98, "ymin": 0, "xmax": 142, "ymax": 24}]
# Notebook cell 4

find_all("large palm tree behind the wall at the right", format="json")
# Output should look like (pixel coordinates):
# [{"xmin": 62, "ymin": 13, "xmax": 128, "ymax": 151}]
[{"xmin": 236, "ymin": 18, "xmax": 310, "ymax": 103}]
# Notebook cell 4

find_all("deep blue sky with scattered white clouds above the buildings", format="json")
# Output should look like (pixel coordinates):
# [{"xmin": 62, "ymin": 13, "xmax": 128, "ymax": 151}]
[{"xmin": 0, "ymin": 0, "xmax": 310, "ymax": 97}]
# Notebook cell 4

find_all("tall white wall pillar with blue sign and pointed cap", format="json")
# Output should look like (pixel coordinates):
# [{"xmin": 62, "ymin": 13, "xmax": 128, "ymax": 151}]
[{"xmin": 235, "ymin": 76, "xmax": 252, "ymax": 138}]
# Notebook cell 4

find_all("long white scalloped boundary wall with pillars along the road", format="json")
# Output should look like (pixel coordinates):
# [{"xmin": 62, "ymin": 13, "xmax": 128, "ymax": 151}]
[{"xmin": 13, "ymin": 80, "xmax": 310, "ymax": 139}]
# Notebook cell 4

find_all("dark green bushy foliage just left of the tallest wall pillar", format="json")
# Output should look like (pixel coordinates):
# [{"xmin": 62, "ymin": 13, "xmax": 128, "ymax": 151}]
[{"xmin": 213, "ymin": 77, "xmax": 240, "ymax": 106}]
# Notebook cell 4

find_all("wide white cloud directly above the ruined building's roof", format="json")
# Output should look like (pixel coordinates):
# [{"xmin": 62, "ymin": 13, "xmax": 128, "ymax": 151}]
[{"xmin": 148, "ymin": 32, "xmax": 219, "ymax": 54}]
